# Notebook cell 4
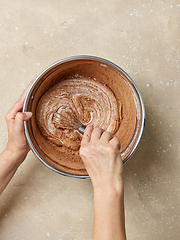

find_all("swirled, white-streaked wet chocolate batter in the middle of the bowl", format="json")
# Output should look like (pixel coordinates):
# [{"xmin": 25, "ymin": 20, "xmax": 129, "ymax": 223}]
[{"xmin": 36, "ymin": 77, "xmax": 120, "ymax": 154}]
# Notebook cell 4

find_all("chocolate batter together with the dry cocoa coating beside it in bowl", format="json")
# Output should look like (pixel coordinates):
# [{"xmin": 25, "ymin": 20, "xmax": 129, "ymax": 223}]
[{"xmin": 36, "ymin": 74, "xmax": 136, "ymax": 175}]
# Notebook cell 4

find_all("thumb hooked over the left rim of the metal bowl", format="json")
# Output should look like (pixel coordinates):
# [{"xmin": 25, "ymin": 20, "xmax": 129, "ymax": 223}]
[{"xmin": 14, "ymin": 112, "xmax": 32, "ymax": 136}]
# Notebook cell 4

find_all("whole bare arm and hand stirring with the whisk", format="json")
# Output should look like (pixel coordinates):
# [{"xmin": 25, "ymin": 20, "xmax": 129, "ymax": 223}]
[{"xmin": 80, "ymin": 125, "xmax": 126, "ymax": 240}]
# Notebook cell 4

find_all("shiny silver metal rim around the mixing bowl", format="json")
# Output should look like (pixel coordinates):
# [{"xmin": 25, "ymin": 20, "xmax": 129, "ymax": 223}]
[{"xmin": 23, "ymin": 55, "xmax": 146, "ymax": 179}]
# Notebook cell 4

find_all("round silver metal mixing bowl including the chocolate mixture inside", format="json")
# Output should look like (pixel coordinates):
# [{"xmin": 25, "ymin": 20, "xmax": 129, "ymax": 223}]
[{"xmin": 23, "ymin": 56, "xmax": 145, "ymax": 178}]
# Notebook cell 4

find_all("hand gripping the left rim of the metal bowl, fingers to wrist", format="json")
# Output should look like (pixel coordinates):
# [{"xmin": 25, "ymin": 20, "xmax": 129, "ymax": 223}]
[{"xmin": 5, "ymin": 89, "xmax": 32, "ymax": 157}]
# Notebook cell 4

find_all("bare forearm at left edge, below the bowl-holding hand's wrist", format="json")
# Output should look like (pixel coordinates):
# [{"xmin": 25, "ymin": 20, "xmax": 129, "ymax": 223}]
[{"xmin": 0, "ymin": 149, "xmax": 27, "ymax": 194}]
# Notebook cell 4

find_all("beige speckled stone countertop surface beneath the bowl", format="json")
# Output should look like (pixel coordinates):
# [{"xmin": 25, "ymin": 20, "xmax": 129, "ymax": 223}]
[{"xmin": 0, "ymin": 0, "xmax": 180, "ymax": 240}]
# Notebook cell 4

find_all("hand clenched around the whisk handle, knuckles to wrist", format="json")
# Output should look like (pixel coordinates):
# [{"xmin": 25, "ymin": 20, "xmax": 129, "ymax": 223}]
[{"xmin": 80, "ymin": 125, "xmax": 123, "ymax": 189}]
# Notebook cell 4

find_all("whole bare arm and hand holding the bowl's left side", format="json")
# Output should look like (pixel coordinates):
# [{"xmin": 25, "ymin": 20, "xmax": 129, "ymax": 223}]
[{"xmin": 0, "ymin": 89, "xmax": 32, "ymax": 194}]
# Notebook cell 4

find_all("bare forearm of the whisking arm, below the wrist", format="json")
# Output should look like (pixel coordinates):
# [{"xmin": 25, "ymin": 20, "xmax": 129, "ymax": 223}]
[{"xmin": 93, "ymin": 185, "xmax": 126, "ymax": 240}]
